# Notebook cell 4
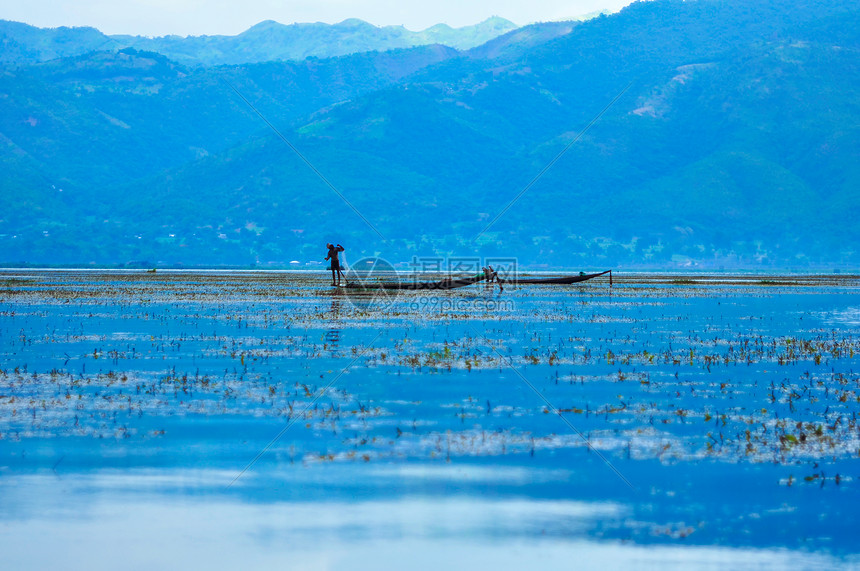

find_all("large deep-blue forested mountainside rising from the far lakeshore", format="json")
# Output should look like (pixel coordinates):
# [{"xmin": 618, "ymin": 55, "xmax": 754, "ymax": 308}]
[{"xmin": 0, "ymin": 0, "xmax": 860, "ymax": 271}]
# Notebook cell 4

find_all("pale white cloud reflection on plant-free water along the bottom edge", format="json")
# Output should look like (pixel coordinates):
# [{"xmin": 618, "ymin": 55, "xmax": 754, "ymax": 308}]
[{"xmin": 0, "ymin": 473, "xmax": 858, "ymax": 570}]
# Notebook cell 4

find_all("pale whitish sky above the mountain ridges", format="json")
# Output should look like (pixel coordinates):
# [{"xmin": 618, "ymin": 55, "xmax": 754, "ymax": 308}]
[{"xmin": 0, "ymin": 0, "xmax": 630, "ymax": 36}]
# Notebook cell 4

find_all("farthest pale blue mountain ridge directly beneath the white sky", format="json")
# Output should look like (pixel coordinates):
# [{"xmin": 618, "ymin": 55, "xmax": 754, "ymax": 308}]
[{"xmin": 0, "ymin": 17, "xmax": 517, "ymax": 66}]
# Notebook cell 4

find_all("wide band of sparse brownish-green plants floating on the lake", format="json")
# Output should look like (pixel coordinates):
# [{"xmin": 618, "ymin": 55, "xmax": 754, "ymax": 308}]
[{"xmin": 0, "ymin": 272, "xmax": 860, "ymax": 476}]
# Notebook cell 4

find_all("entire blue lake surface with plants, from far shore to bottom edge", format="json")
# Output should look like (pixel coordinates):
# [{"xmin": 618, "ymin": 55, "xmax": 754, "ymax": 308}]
[{"xmin": 0, "ymin": 271, "xmax": 860, "ymax": 569}]
